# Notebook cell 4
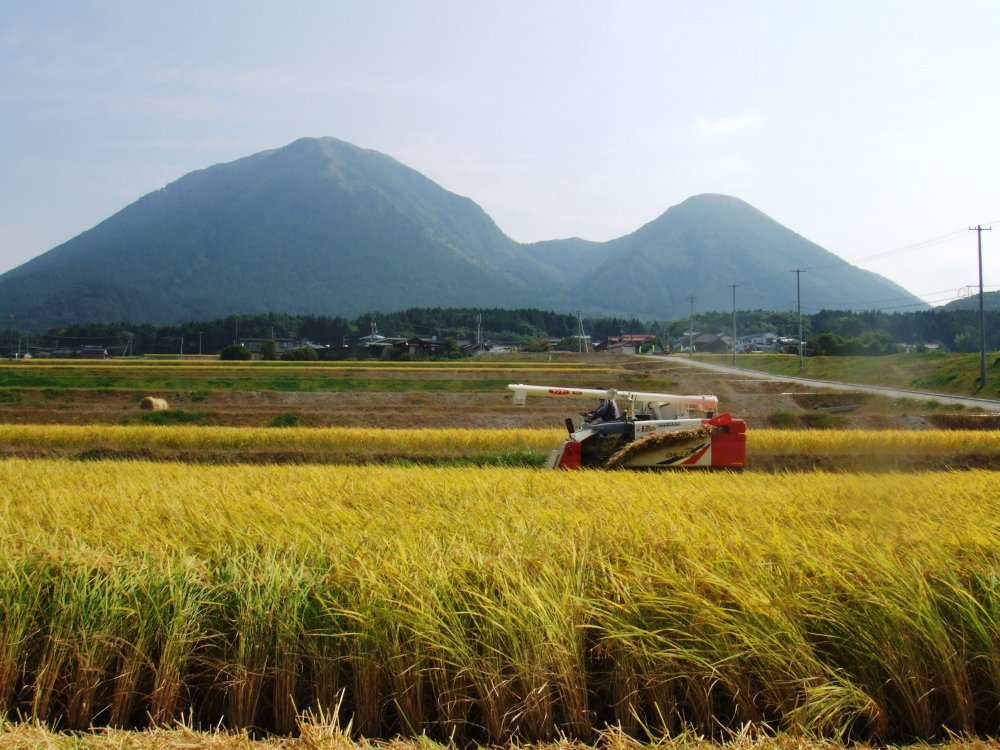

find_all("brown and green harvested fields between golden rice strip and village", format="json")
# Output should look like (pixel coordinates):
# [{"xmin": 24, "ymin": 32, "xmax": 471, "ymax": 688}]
[{"xmin": 0, "ymin": 355, "xmax": 984, "ymax": 429}]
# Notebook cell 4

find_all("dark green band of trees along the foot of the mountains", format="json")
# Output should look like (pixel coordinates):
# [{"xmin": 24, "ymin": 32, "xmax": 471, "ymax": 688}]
[{"xmin": 9, "ymin": 308, "xmax": 1000, "ymax": 356}]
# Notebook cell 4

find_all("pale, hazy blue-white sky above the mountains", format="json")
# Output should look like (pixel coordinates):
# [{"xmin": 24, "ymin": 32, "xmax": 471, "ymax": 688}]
[{"xmin": 0, "ymin": 0, "xmax": 1000, "ymax": 307}]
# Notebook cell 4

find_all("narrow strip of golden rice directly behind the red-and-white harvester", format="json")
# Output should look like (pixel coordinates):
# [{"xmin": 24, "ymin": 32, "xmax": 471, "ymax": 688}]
[{"xmin": 0, "ymin": 424, "xmax": 1000, "ymax": 471}]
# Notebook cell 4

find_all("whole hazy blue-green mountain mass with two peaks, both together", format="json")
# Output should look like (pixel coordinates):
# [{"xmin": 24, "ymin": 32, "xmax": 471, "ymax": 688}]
[{"xmin": 0, "ymin": 138, "xmax": 919, "ymax": 330}]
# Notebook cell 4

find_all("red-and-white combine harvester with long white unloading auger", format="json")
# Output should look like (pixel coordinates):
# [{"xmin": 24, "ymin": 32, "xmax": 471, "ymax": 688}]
[{"xmin": 507, "ymin": 384, "xmax": 746, "ymax": 469}]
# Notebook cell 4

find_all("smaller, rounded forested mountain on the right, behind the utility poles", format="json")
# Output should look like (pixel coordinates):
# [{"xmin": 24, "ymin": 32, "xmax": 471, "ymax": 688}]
[{"xmin": 570, "ymin": 195, "xmax": 925, "ymax": 317}]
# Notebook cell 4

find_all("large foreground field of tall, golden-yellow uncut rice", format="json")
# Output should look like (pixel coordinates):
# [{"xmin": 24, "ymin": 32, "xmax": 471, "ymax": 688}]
[{"xmin": 0, "ymin": 459, "xmax": 1000, "ymax": 743}]
